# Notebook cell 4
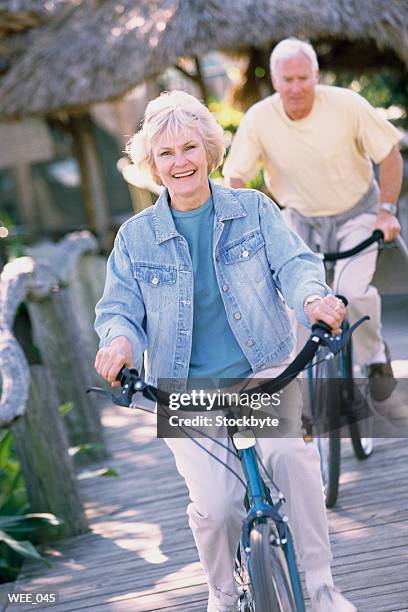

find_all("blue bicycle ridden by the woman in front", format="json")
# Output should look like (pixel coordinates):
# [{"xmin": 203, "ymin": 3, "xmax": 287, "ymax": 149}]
[{"xmin": 88, "ymin": 317, "xmax": 368, "ymax": 612}]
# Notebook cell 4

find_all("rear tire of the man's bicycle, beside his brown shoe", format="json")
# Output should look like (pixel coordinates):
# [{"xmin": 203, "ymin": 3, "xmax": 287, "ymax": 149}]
[{"xmin": 343, "ymin": 330, "xmax": 374, "ymax": 461}]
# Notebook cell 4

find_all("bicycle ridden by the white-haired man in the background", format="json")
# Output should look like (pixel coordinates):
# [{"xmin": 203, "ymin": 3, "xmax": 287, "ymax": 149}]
[{"xmin": 306, "ymin": 230, "xmax": 384, "ymax": 508}]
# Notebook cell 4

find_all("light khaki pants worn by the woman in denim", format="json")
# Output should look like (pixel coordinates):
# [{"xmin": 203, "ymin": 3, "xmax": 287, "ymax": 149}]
[{"xmin": 165, "ymin": 365, "xmax": 331, "ymax": 606}]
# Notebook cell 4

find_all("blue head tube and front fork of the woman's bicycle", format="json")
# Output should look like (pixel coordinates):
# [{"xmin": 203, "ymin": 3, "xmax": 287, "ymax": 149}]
[{"xmin": 238, "ymin": 438, "xmax": 305, "ymax": 612}]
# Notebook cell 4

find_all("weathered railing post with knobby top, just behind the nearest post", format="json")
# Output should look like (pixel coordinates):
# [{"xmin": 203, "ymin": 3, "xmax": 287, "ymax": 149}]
[{"xmin": 27, "ymin": 232, "xmax": 106, "ymax": 460}]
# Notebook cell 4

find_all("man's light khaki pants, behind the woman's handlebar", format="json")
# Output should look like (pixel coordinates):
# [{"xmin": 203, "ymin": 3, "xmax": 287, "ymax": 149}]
[{"xmin": 283, "ymin": 209, "xmax": 383, "ymax": 367}]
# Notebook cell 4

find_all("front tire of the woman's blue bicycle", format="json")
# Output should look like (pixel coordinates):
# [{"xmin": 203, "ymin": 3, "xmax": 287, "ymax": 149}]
[{"xmin": 250, "ymin": 523, "xmax": 296, "ymax": 612}]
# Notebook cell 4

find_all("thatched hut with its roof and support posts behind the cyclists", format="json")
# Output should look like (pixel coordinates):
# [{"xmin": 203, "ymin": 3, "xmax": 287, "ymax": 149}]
[{"xmin": 0, "ymin": 0, "xmax": 408, "ymax": 246}]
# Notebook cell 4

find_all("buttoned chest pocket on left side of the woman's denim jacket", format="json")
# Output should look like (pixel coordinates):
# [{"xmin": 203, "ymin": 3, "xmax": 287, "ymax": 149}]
[{"xmin": 132, "ymin": 262, "xmax": 177, "ymax": 316}]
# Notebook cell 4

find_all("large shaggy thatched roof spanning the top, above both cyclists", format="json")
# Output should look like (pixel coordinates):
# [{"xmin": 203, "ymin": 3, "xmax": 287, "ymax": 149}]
[{"xmin": 0, "ymin": 0, "xmax": 408, "ymax": 118}]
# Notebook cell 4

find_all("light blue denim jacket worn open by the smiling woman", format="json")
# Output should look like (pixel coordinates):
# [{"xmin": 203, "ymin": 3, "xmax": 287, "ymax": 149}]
[{"xmin": 95, "ymin": 182, "xmax": 330, "ymax": 384}]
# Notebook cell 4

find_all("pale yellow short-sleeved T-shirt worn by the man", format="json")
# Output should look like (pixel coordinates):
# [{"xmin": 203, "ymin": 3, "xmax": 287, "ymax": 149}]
[{"xmin": 223, "ymin": 85, "xmax": 402, "ymax": 217}]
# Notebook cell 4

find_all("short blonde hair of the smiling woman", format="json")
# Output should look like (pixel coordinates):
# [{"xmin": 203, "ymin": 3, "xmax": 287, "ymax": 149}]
[{"xmin": 126, "ymin": 90, "xmax": 225, "ymax": 184}]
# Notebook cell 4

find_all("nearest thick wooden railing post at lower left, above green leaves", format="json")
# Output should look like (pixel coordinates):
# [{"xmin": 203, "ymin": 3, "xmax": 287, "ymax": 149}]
[{"xmin": 13, "ymin": 365, "xmax": 88, "ymax": 537}]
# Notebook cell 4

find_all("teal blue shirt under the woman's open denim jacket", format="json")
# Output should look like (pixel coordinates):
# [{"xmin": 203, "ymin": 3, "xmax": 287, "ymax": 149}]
[{"xmin": 171, "ymin": 197, "xmax": 252, "ymax": 378}]
